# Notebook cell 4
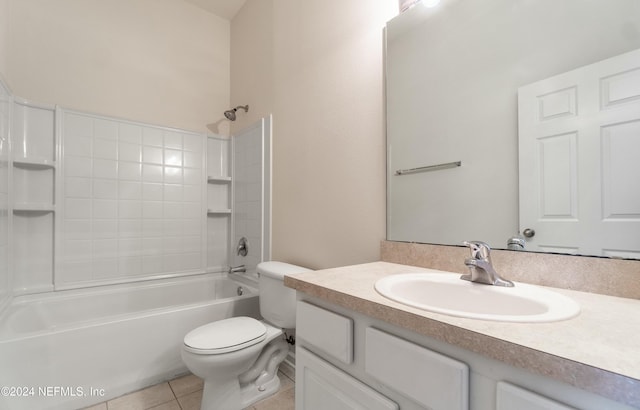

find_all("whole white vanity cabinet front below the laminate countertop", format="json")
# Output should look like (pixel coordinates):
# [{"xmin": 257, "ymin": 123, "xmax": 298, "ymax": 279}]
[{"xmin": 296, "ymin": 292, "xmax": 632, "ymax": 410}]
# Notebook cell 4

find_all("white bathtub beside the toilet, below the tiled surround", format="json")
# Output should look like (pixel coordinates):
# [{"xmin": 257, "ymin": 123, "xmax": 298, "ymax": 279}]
[{"xmin": 0, "ymin": 274, "xmax": 259, "ymax": 410}]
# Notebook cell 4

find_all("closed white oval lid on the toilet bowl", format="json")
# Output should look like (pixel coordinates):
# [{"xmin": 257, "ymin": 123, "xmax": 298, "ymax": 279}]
[{"xmin": 184, "ymin": 316, "xmax": 267, "ymax": 354}]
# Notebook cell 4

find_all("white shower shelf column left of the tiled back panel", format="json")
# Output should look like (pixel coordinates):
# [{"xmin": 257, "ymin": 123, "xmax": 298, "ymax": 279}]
[{"xmin": 9, "ymin": 98, "xmax": 59, "ymax": 294}]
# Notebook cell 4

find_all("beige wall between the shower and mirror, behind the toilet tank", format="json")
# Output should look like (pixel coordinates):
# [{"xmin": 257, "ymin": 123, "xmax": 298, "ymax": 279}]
[{"xmin": 231, "ymin": 0, "xmax": 398, "ymax": 269}]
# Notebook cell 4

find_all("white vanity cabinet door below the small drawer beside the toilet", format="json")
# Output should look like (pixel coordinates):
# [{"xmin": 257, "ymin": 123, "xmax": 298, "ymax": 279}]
[{"xmin": 296, "ymin": 347, "xmax": 398, "ymax": 410}]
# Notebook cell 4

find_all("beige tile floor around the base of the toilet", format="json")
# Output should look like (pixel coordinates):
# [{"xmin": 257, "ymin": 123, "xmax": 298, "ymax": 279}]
[{"xmin": 85, "ymin": 365, "xmax": 295, "ymax": 410}]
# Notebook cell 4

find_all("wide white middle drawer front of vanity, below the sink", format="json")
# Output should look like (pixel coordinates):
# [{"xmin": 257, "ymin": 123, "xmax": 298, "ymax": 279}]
[{"xmin": 365, "ymin": 327, "xmax": 469, "ymax": 410}]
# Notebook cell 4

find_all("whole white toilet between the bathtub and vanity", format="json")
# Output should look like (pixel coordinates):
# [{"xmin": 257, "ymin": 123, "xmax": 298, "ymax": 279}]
[{"xmin": 182, "ymin": 262, "xmax": 309, "ymax": 410}]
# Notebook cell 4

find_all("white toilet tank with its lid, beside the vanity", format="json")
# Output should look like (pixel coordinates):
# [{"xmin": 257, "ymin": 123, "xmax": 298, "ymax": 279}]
[{"xmin": 257, "ymin": 261, "xmax": 310, "ymax": 329}]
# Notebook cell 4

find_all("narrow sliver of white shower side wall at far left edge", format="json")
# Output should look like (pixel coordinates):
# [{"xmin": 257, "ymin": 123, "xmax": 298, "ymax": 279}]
[{"xmin": 0, "ymin": 81, "xmax": 11, "ymax": 306}]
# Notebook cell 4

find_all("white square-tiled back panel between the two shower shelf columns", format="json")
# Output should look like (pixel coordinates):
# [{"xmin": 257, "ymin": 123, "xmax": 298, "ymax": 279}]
[{"xmin": 55, "ymin": 111, "xmax": 206, "ymax": 288}]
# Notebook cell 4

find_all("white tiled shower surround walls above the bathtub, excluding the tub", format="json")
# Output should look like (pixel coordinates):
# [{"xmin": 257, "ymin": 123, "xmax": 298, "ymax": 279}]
[{"xmin": 0, "ymin": 89, "xmax": 270, "ymax": 296}]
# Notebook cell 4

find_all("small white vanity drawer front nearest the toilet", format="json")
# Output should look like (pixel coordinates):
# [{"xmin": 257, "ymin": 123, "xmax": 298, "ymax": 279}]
[{"xmin": 296, "ymin": 301, "xmax": 353, "ymax": 364}]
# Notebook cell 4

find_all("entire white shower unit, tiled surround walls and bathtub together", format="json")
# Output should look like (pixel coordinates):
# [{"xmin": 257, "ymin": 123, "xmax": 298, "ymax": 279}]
[{"xmin": 0, "ymin": 82, "xmax": 271, "ymax": 408}]
